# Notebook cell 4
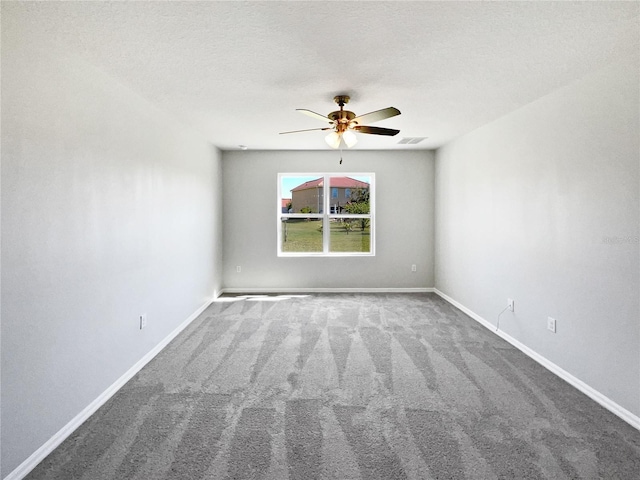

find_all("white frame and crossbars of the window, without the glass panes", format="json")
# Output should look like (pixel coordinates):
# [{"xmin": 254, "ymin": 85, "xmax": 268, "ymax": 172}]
[{"xmin": 276, "ymin": 172, "xmax": 376, "ymax": 257}]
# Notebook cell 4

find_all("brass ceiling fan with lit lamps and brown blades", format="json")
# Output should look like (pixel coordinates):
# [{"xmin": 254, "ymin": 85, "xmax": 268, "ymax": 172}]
[{"xmin": 280, "ymin": 95, "xmax": 400, "ymax": 148}]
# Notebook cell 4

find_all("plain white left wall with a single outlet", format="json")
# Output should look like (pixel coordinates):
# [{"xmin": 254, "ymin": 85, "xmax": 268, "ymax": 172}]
[{"xmin": 1, "ymin": 28, "xmax": 222, "ymax": 477}]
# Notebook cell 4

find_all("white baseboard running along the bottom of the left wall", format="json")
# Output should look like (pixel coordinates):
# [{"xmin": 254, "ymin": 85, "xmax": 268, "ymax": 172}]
[{"xmin": 4, "ymin": 300, "xmax": 212, "ymax": 480}]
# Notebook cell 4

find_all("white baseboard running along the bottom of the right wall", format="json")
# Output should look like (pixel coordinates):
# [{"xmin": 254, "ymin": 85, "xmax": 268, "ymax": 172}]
[{"xmin": 434, "ymin": 288, "xmax": 640, "ymax": 430}]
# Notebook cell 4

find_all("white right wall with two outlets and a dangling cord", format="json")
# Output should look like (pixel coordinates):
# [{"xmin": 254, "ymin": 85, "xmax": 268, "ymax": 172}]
[{"xmin": 435, "ymin": 54, "xmax": 640, "ymax": 416}]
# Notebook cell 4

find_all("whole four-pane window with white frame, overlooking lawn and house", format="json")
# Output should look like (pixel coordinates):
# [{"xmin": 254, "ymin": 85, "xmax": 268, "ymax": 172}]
[{"xmin": 277, "ymin": 173, "xmax": 375, "ymax": 256}]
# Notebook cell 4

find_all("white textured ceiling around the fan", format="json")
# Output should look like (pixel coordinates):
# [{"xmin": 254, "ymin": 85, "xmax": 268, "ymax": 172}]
[{"xmin": 2, "ymin": 1, "xmax": 640, "ymax": 150}]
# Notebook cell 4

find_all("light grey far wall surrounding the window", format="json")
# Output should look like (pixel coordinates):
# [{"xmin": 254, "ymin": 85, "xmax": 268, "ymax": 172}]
[{"xmin": 222, "ymin": 150, "xmax": 434, "ymax": 290}]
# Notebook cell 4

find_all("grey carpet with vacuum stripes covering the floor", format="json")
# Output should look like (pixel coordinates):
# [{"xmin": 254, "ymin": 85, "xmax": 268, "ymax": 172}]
[{"xmin": 27, "ymin": 294, "xmax": 640, "ymax": 480}]
